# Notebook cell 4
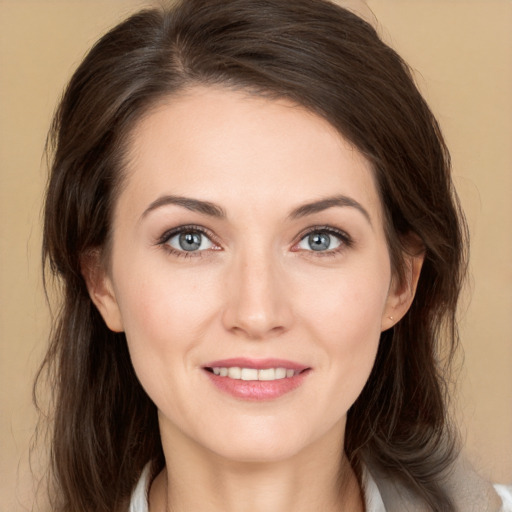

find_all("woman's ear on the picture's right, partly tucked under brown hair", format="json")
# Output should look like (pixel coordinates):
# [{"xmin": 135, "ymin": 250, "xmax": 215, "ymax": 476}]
[{"xmin": 381, "ymin": 240, "xmax": 425, "ymax": 331}]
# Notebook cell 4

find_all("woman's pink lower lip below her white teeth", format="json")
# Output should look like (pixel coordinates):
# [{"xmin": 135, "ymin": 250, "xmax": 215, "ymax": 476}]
[{"xmin": 205, "ymin": 370, "xmax": 309, "ymax": 401}]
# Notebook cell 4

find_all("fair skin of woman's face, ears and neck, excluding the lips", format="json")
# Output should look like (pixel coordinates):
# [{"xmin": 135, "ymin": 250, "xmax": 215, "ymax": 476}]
[{"xmin": 84, "ymin": 87, "xmax": 421, "ymax": 512}]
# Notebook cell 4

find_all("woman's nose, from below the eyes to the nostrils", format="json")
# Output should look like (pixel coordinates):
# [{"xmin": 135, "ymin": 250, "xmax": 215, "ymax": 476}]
[{"xmin": 222, "ymin": 245, "xmax": 293, "ymax": 340}]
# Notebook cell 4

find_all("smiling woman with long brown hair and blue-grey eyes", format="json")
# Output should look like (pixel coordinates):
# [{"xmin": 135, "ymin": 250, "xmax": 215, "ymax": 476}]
[{"xmin": 36, "ymin": 0, "xmax": 508, "ymax": 512}]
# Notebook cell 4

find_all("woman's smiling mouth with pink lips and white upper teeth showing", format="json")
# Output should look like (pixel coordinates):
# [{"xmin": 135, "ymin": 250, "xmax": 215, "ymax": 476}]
[{"xmin": 203, "ymin": 358, "xmax": 312, "ymax": 401}]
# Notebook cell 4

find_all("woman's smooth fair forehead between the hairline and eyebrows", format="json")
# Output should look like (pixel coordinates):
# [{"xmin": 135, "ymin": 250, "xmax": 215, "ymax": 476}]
[{"xmin": 120, "ymin": 87, "xmax": 380, "ymax": 222}]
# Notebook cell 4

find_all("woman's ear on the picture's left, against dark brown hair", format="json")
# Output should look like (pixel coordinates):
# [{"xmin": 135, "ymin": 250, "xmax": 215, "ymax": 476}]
[{"xmin": 80, "ymin": 249, "xmax": 124, "ymax": 332}]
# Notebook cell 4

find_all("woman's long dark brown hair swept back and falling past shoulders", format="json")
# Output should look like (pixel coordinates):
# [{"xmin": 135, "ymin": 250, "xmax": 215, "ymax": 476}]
[{"xmin": 36, "ymin": 0, "xmax": 465, "ymax": 512}]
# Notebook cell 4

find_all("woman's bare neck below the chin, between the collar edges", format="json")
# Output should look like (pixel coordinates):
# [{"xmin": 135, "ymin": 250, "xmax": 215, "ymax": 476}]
[{"xmin": 150, "ymin": 420, "xmax": 364, "ymax": 512}]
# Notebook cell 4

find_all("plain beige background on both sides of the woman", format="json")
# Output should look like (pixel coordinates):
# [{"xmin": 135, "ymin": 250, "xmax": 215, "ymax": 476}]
[{"xmin": 0, "ymin": 0, "xmax": 512, "ymax": 512}]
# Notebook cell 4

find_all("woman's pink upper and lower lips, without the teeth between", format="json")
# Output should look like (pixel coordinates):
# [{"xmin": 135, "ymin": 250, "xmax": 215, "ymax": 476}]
[{"xmin": 203, "ymin": 357, "xmax": 311, "ymax": 401}]
